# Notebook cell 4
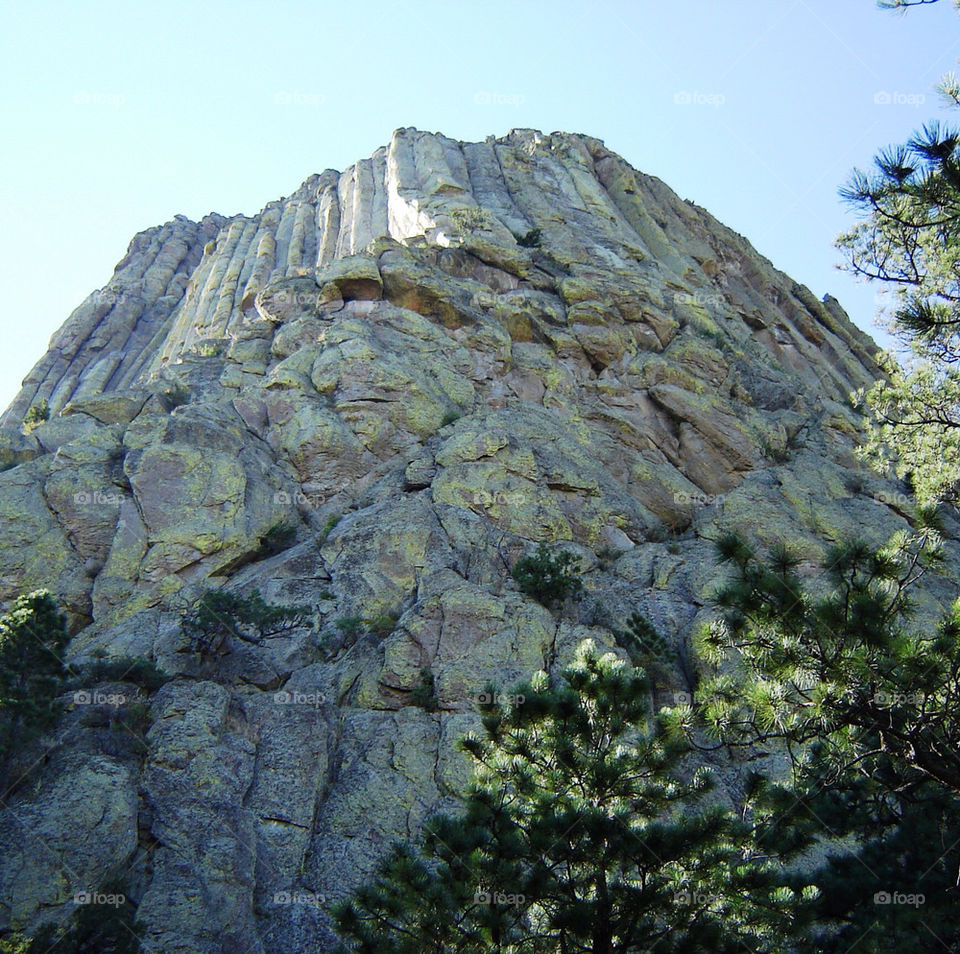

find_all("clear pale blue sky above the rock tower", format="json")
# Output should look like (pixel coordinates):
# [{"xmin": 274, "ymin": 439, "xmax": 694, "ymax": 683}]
[{"xmin": 0, "ymin": 0, "xmax": 960, "ymax": 407}]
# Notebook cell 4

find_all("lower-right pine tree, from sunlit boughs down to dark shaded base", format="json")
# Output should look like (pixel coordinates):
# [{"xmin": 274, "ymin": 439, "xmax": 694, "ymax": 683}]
[{"xmin": 688, "ymin": 515, "xmax": 960, "ymax": 954}]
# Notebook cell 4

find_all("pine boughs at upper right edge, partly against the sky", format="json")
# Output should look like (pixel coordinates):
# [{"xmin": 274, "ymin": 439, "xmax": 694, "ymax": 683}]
[{"xmin": 837, "ymin": 0, "xmax": 960, "ymax": 502}]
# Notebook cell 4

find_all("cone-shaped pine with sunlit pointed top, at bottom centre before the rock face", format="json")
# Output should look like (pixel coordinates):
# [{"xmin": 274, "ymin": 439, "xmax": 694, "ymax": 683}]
[{"xmin": 336, "ymin": 641, "xmax": 809, "ymax": 954}]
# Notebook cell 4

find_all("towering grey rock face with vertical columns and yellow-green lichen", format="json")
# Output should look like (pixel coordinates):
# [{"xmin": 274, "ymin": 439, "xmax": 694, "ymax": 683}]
[{"xmin": 0, "ymin": 129, "xmax": 936, "ymax": 954}]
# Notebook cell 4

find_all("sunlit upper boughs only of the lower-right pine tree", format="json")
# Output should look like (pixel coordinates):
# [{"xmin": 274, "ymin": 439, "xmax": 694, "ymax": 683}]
[{"xmin": 699, "ymin": 528, "xmax": 960, "ymax": 794}]
